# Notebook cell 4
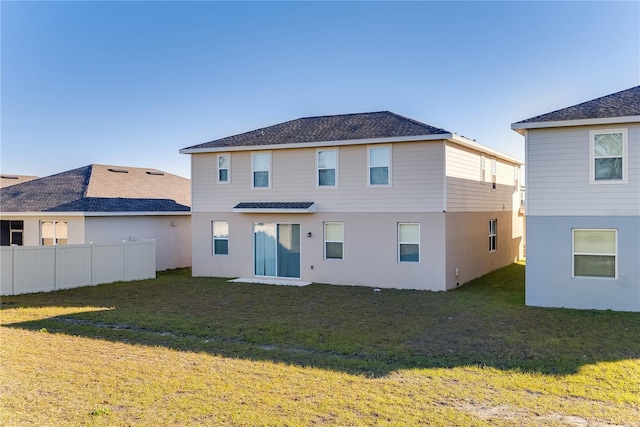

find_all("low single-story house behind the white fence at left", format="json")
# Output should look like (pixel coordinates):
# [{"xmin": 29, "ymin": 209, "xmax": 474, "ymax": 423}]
[{"xmin": 0, "ymin": 164, "xmax": 191, "ymax": 270}]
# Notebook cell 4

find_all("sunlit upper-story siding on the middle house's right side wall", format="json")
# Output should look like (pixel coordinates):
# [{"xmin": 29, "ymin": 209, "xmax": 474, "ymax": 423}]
[{"xmin": 447, "ymin": 144, "xmax": 519, "ymax": 212}]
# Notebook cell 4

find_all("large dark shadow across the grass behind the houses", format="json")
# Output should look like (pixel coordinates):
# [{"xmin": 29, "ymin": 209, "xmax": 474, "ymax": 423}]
[{"xmin": 2, "ymin": 264, "xmax": 640, "ymax": 377}]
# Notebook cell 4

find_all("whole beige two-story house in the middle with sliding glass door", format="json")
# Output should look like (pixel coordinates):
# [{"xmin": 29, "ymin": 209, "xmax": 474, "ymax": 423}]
[{"xmin": 180, "ymin": 112, "xmax": 523, "ymax": 291}]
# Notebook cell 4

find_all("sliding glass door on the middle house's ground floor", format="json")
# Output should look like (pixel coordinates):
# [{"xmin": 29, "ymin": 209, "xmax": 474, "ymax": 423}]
[{"xmin": 253, "ymin": 223, "xmax": 300, "ymax": 278}]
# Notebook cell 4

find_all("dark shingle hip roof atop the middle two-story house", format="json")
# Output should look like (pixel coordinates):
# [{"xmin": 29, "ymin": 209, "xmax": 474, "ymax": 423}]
[{"xmin": 180, "ymin": 111, "xmax": 451, "ymax": 150}]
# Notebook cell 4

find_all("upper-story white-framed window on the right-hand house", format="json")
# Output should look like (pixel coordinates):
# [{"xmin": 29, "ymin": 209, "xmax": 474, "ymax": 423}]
[{"xmin": 589, "ymin": 129, "xmax": 628, "ymax": 184}]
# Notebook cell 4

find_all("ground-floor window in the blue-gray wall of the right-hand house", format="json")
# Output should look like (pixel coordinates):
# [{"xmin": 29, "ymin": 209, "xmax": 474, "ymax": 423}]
[{"xmin": 573, "ymin": 229, "xmax": 618, "ymax": 279}]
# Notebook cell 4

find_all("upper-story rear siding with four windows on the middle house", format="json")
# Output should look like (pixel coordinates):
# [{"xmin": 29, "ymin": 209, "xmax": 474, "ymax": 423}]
[{"xmin": 191, "ymin": 141, "xmax": 443, "ymax": 212}]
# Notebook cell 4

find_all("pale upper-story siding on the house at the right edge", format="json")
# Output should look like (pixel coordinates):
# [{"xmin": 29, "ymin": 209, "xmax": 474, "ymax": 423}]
[{"xmin": 527, "ymin": 125, "xmax": 640, "ymax": 215}]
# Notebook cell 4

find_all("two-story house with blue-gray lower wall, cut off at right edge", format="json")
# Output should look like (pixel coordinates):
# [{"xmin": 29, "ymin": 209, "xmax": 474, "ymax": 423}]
[{"xmin": 511, "ymin": 86, "xmax": 640, "ymax": 311}]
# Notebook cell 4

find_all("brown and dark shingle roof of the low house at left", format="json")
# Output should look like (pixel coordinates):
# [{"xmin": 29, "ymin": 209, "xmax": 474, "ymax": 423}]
[{"xmin": 0, "ymin": 165, "xmax": 191, "ymax": 216}]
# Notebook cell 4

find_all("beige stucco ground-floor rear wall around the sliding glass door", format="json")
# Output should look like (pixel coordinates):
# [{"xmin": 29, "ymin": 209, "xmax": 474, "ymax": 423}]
[{"xmin": 192, "ymin": 212, "xmax": 445, "ymax": 290}]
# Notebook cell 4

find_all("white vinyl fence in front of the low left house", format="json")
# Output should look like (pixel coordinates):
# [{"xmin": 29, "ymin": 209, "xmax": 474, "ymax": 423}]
[{"xmin": 0, "ymin": 240, "xmax": 156, "ymax": 295}]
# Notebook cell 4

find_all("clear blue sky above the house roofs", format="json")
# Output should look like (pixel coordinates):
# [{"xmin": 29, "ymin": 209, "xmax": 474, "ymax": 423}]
[{"xmin": 0, "ymin": 1, "xmax": 640, "ymax": 177}]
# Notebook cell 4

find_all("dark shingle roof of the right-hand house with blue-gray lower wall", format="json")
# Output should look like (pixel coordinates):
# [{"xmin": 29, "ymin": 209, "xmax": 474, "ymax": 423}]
[{"xmin": 513, "ymin": 86, "xmax": 640, "ymax": 129}]
